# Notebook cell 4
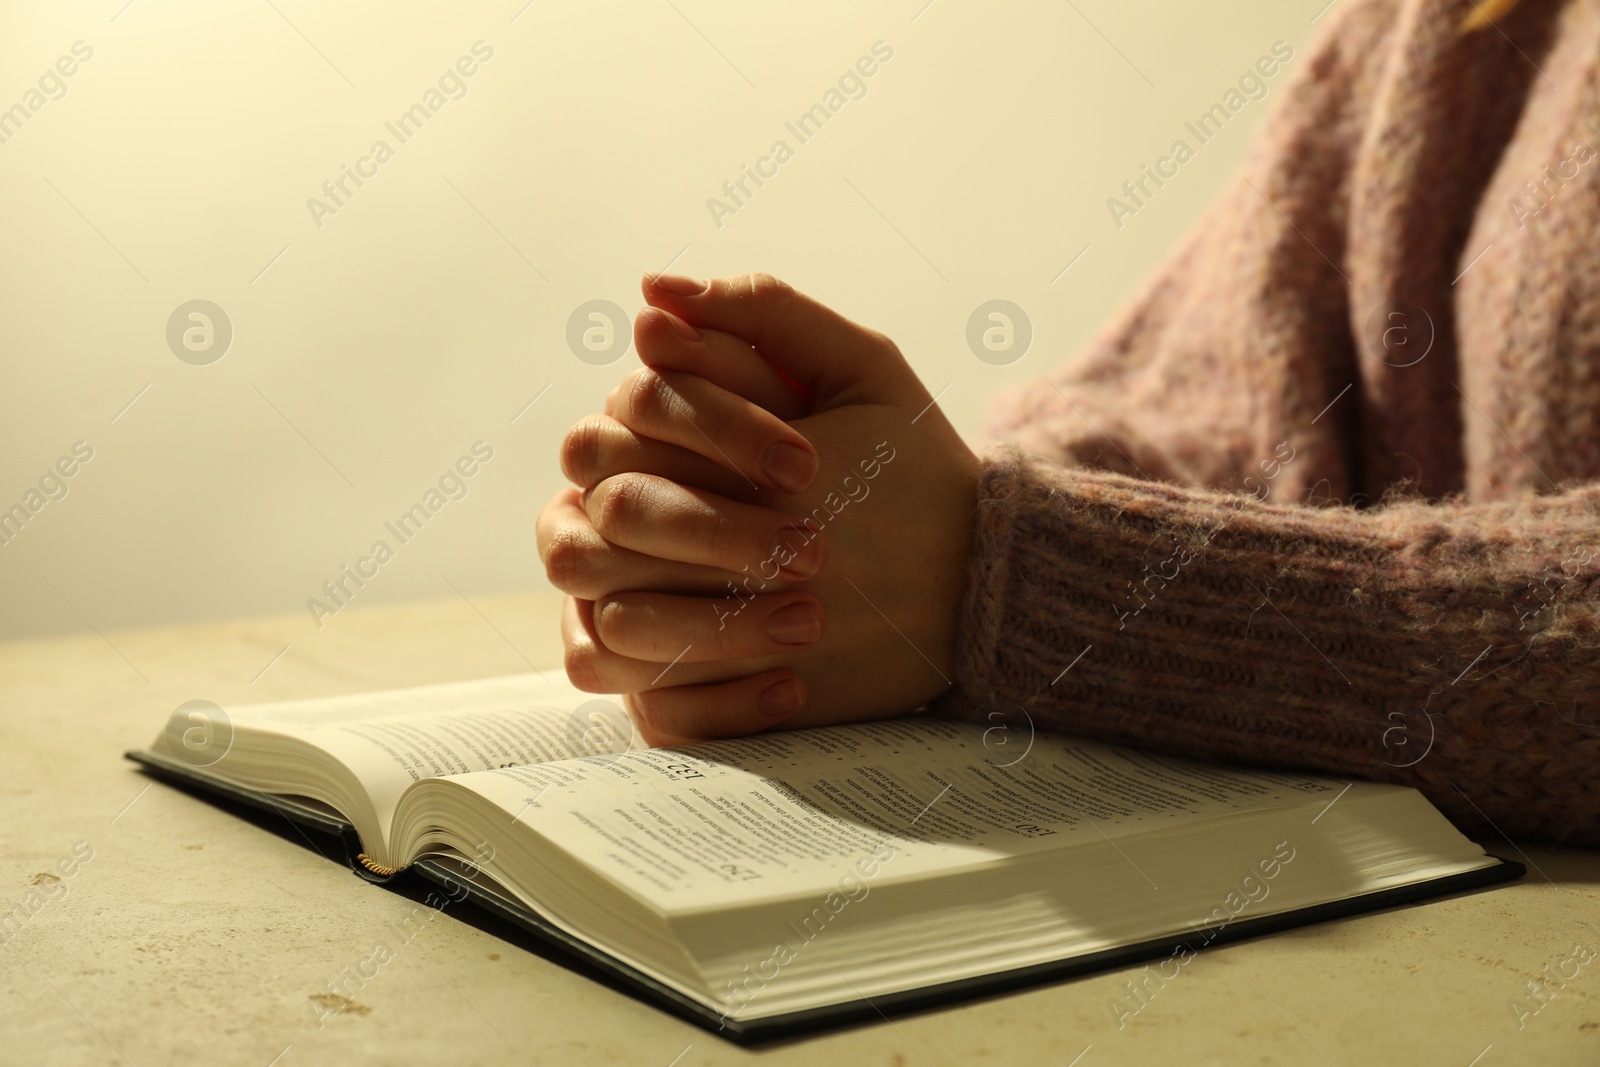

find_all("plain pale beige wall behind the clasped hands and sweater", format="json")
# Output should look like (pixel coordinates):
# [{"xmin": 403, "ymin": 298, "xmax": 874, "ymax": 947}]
[{"xmin": 0, "ymin": 0, "xmax": 1323, "ymax": 641}]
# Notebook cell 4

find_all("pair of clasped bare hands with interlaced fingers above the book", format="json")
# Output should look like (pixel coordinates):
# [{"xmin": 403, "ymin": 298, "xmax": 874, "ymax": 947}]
[{"xmin": 538, "ymin": 274, "xmax": 978, "ymax": 744}]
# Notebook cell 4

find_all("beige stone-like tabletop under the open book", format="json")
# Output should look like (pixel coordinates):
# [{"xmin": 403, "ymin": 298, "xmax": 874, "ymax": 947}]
[{"xmin": 0, "ymin": 595, "xmax": 1600, "ymax": 1067}]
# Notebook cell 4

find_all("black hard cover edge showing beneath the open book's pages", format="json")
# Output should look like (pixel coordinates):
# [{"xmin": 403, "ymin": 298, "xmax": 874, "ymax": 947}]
[{"xmin": 126, "ymin": 750, "xmax": 1528, "ymax": 1045}]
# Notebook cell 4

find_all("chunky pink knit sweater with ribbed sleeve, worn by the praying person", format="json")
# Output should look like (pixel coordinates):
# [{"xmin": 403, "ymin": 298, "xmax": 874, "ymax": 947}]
[{"xmin": 938, "ymin": 0, "xmax": 1600, "ymax": 846}]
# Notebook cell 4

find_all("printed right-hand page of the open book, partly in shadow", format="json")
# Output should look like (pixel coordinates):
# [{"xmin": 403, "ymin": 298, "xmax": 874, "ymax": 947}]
[{"xmin": 441, "ymin": 717, "xmax": 1350, "ymax": 910}]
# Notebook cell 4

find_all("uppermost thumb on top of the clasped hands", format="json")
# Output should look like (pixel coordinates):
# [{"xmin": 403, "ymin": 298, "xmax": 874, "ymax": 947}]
[{"xmin": 643, "ymin": 274, "xmax": 925, "ymax": 400}]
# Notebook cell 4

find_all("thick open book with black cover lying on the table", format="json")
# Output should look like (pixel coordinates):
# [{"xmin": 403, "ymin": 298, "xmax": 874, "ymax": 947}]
[{"xmin": 130, "ymin": 675, "xmax": 1523, "ymax": 1038}]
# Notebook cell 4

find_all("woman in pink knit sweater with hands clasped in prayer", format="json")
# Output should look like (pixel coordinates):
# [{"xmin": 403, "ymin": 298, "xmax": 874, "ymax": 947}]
[{"xmin": 539, "ymin": 0, "xmax": 1600, "ymax": 846}]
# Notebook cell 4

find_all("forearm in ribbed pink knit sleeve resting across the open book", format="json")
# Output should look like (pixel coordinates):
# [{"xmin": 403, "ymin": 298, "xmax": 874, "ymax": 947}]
[{"xmin": 939, "ymin": 453, "xmax": 1600, "ymax": 845}]
